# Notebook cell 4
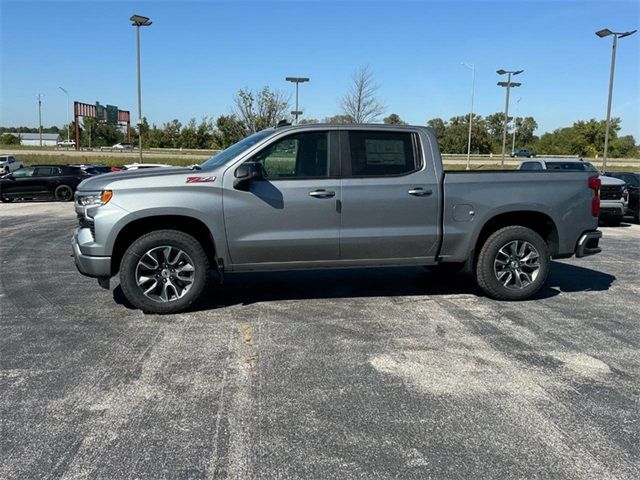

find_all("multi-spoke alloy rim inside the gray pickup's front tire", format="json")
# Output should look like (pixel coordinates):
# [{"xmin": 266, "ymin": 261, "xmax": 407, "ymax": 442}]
[{"xmin": 136, "ymin": 246, "xmax": 195, "ymax": 303}]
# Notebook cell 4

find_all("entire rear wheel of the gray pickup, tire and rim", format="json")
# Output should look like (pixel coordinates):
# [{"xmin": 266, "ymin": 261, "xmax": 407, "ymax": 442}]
[{"xmin": 476, "ymin": 225, "xmax": 551, "ymax": 300}]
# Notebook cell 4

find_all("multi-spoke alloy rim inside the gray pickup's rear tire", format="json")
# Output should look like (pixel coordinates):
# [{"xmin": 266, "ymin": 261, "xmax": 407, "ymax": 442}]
[{"xmin": 493, "ymin": 240, "xmax": 540, "ymax": 290}]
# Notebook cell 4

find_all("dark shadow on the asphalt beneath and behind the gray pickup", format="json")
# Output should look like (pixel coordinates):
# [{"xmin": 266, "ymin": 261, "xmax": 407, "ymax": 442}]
[{"xmin": 113, "ymin": 261, "xmax": 616, "ymax": 312}]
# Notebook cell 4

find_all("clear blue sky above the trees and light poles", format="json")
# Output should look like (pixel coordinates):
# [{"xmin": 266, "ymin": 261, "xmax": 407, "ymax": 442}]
[{"xmin": 0, "ymin": 0, "xmax": 640, "ymax": 135}]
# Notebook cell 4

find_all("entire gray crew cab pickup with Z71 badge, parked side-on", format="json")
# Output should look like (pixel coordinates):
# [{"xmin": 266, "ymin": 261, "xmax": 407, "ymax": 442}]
[{"xmin": 72, "ymin": 124, "xmax": 601, "ymax": 313}]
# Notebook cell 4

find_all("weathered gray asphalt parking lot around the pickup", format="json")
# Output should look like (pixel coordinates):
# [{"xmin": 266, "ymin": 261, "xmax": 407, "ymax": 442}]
[{"xmin": 0, "ymin": 202, "xmax": 640, "ymax": 479}]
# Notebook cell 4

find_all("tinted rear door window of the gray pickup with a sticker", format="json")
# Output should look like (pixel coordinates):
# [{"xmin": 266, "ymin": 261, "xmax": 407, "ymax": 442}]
[{"xmin": 349, "ymin": 130, "xmax": 421, "ymax": 177}]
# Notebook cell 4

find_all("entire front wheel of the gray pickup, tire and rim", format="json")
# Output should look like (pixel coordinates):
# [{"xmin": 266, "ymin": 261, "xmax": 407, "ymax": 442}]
[{"xmin": 120, "ymin": 230, "xmax": 209, "ymax": 313}]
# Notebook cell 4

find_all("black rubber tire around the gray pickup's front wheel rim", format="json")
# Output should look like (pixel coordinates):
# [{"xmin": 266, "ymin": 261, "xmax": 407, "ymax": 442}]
[{"xmin": 120, "ymin": 230, "xmax": 209, "ymax": 314}]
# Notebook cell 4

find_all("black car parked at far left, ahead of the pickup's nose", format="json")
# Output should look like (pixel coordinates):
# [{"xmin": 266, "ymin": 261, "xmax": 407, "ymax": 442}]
[{"xmin": 0, "ymin": 165, "xmax": 89, "ymax": 202}]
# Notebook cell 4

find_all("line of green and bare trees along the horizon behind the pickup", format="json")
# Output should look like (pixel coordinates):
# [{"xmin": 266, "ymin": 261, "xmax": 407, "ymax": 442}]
[{"xmin": 0, "ymin": 65, "xmax": 640, "ymax": 158}]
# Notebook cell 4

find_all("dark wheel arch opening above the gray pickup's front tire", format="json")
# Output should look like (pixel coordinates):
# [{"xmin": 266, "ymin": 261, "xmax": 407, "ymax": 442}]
[{"xmin": 111, "ymin": 215, "xmax": 217, "ymax": 276}]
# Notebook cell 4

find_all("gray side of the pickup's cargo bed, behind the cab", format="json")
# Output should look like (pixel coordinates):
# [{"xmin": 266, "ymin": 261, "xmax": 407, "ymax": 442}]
[{"xmin": 440, "ymin": 170, "xmax": 598, "ymax": 261}]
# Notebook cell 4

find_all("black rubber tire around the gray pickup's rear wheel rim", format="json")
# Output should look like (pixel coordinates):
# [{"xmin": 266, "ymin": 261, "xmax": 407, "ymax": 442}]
[{"xmin": 476, "ymin": 225, "xmax": 551, "ymax": 300}]
